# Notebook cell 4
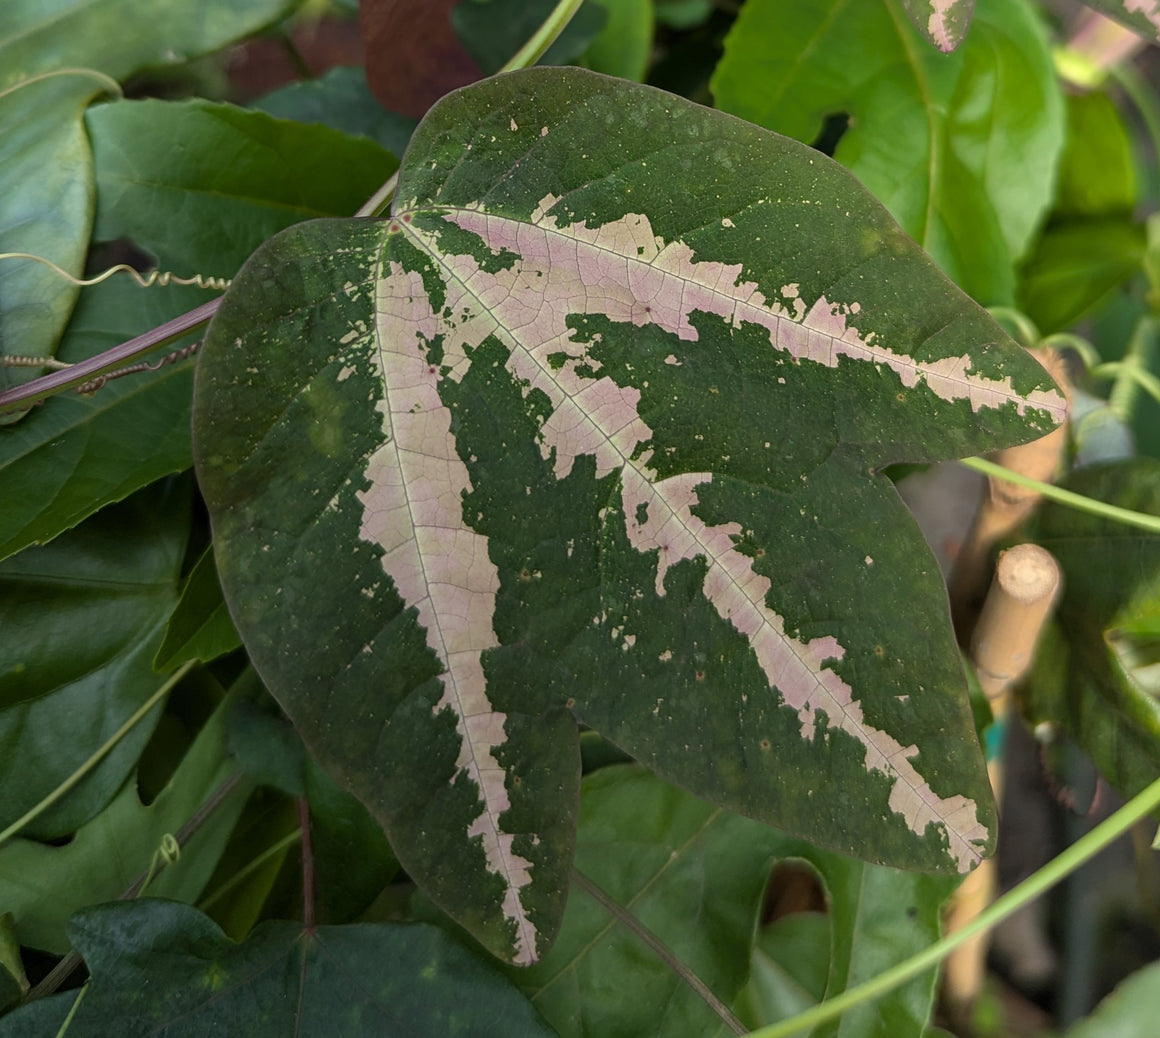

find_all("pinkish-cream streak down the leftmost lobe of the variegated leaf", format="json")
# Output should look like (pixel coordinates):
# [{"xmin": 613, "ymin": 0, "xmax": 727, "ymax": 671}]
[{"xmin": 358, "ymin": 261, "xmax": 537, "ymax": 965}]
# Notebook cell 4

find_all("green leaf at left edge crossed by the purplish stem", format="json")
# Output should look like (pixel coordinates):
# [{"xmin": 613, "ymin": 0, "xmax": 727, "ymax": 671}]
[{"xmin": 0, "ymin": 277, "xmax": 200, "ymax": 559}]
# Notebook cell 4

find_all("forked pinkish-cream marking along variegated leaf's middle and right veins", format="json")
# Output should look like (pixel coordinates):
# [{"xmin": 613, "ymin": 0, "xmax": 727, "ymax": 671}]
[{"xmin": 382, "ymin": 196, "xmax": 1025, "ymax": 871}]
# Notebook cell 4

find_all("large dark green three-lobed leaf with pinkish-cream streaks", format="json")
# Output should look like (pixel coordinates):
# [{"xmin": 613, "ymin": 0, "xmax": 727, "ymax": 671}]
[{"xmin": 194, "ymin": 68, "xmax": 1064, "ymax": 964}]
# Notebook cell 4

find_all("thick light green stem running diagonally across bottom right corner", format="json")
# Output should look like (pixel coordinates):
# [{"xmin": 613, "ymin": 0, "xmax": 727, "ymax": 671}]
[{"xmin": 752, "ymin": 778, "xmax": 1160, "ymax": 1038}]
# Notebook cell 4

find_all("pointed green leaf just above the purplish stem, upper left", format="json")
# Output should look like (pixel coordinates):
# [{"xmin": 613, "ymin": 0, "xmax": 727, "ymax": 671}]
[{"xmin": 86, "ymin": 100, "xmax": 398, "ymax": 277}]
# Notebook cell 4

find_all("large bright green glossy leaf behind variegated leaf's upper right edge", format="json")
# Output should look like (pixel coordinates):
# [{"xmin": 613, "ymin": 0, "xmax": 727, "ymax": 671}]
[{"xmin": 712, "ymin": 0, "xmax": 1064, "ymax": 304}]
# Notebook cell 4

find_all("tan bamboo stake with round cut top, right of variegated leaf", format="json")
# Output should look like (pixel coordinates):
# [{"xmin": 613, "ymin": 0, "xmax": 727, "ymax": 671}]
[{"xmin": 945, "ymin": 544, "xmax": 1060, "ymax": 1011}]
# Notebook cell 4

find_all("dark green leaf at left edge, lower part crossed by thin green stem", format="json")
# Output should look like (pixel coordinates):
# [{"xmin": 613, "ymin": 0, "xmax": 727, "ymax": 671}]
[{"xmin": 0, "ymin": 482, "xmax": 189, "ymax": 839}]
